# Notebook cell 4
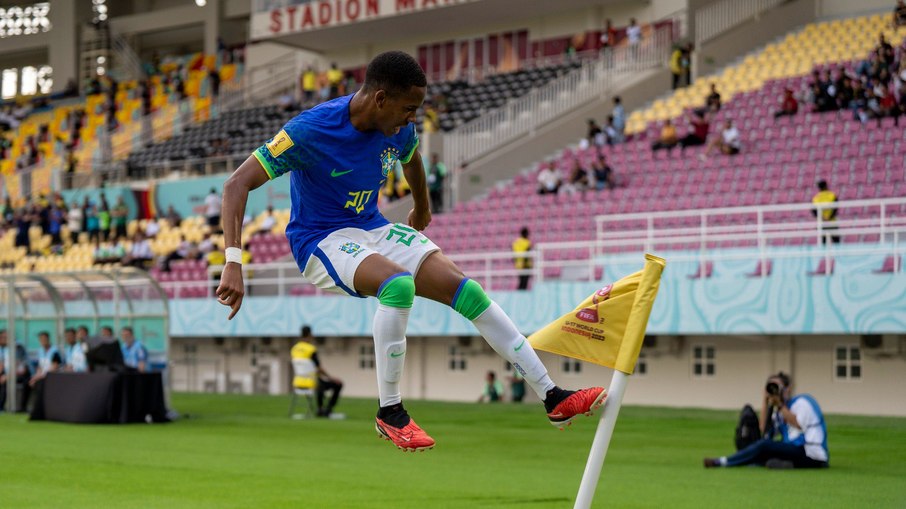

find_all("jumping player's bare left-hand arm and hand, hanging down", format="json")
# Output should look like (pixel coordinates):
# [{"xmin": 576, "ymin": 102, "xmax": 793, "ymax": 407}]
[{"xmin": 216, "ymin": 155, "xmax": 269, "ymax": 320}]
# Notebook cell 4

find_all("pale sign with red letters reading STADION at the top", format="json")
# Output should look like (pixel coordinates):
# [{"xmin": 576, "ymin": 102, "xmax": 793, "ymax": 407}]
[{"xmin": 251, "ymin": 0, "xmax": 478, "ymax": 40}]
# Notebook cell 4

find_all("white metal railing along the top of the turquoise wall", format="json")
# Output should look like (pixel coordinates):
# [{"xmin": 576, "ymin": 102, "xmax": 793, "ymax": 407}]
[{"xmin": 161, "ymin": 194, "xmax": 906, "ymax": 298}]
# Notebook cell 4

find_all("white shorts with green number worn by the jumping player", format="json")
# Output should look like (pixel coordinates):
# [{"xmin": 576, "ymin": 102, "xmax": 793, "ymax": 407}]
[{"xmin": 302, "ymin": 223, "xmax": 440, "ymax": 297}]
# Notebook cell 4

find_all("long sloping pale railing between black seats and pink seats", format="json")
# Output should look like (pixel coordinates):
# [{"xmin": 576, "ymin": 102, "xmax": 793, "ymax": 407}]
[{"xmin": 444, "ymin": 27, "xmax": 673, "ymax": 182}]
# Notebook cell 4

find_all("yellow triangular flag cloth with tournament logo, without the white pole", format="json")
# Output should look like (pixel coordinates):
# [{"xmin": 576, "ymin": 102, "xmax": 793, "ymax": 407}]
[{"xmin": 528, "ymin": 254, "xmax": 666, "ymax": 375}]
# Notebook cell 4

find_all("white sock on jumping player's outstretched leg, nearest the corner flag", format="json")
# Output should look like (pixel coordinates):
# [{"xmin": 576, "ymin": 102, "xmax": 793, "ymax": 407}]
[{"xmin": 472, "ymin": 302, "xmax": 556, "ymax": 401}]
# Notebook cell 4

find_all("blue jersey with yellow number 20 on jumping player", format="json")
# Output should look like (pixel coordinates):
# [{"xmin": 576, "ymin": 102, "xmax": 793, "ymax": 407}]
[{"xmin": 254, "ymin": 95, "xmax": 418, "ymax": 264}]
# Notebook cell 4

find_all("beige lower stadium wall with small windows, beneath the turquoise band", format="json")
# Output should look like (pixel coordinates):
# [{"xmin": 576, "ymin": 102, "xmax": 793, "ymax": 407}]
[{"xmin": 170, "ymin": 330, "xmax": 906, "ymax": 416}]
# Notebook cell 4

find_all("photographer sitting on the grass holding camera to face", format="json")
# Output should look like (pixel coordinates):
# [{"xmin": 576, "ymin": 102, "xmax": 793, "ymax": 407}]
[{"xmin": 704, "ymin": 372, "xmax": 829, "ymax": 468}]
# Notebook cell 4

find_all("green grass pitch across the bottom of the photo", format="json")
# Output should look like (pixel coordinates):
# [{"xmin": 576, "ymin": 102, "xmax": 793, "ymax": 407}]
[{"xmin": 0, "ymin": 394, "xmax": 906, "ymax": 509}]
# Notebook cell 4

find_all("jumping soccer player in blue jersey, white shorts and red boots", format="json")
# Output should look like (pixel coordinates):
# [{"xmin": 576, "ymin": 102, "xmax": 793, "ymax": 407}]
[{"xmin": 217, "ymin": 51, "xmax": 606, "ymax": 451}]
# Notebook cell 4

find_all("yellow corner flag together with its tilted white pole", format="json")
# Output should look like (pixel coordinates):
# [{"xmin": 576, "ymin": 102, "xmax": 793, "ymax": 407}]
[{"xmin": 528, "ymin": 254, "xmax": 666, "ymax": 509}]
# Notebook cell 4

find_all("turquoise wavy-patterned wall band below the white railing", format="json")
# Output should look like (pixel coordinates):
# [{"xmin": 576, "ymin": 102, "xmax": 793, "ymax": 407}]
[{"xmin": 170, "ymin": 252, "xmax": 906, "ymax": 337}]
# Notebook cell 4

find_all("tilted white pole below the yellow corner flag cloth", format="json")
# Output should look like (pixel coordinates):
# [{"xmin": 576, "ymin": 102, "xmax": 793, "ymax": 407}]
[{"xmin": 573, "ymin": 370, "xmax": 629, "ymax": 509}]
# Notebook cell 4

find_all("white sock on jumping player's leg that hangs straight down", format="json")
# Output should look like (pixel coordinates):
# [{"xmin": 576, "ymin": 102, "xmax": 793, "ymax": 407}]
[{"xmin": 374, "ymin": 304, "xmax": 409, "ymax": 407}]
